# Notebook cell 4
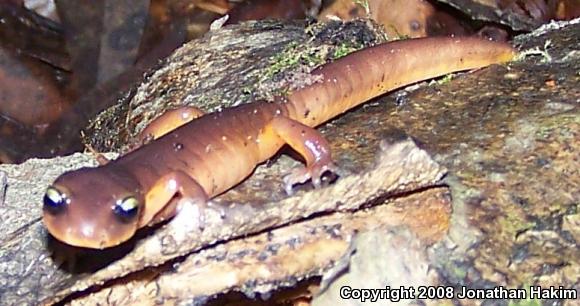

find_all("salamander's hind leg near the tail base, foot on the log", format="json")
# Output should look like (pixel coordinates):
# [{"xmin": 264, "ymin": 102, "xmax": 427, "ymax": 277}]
[{"xmin": 271, "ymin": 117, "xmax": 337, "ymax": 194}]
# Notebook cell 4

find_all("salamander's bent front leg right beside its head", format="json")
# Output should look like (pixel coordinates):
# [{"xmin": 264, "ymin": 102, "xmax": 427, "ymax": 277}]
[{"xmin": 139, "ymin": 171, "xmax": 208, "ymax": 227}]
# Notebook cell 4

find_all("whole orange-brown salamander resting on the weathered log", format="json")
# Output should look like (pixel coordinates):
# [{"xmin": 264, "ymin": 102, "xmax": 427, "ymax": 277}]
[{"xmin": 44, "ymin": 38, "xmax": 515, "ymax": 248}]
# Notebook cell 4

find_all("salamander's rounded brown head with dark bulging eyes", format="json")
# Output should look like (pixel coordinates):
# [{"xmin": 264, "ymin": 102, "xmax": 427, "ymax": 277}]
[{"xmin": 43, "ymin": 166, "xmax": 144, "ymax": 249}]
